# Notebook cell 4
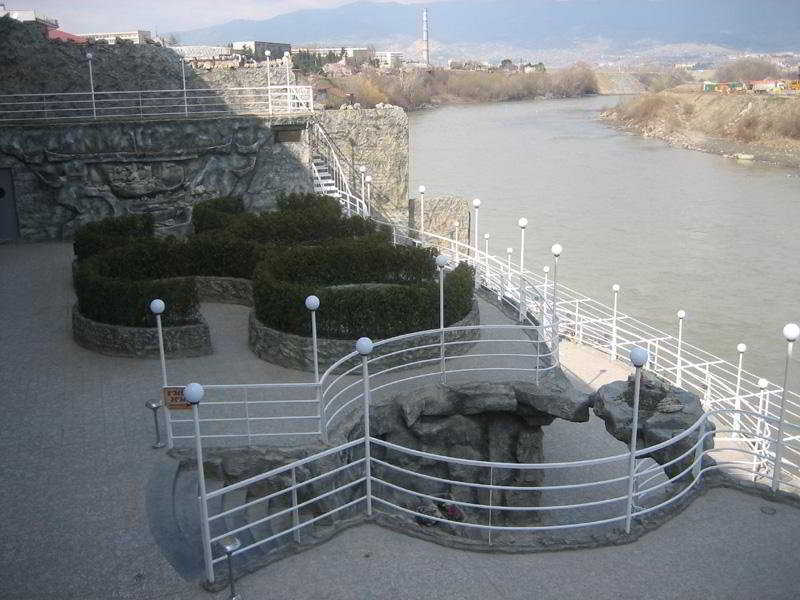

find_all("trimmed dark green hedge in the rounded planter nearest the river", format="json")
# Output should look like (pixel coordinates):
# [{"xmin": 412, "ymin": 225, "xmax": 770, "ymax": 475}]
[{"xmin": 253, "ymin": 238, "xmax": 474, "ymax": 339}]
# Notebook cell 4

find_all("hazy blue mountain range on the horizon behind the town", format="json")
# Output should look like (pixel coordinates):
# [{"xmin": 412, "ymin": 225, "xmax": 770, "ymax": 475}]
[{"xmin": 176, "ymin": 0, "xmax": 800, "ymax": 62}]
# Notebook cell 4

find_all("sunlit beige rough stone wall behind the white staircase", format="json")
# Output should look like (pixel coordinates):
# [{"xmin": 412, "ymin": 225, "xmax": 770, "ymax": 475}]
[{"xmin": 318, "ymin": 107, "xmax": 409, "ymax": 222}]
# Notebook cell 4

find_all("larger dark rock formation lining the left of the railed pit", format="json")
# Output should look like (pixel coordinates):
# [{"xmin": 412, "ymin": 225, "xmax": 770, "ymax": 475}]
[{"xmin": 348, "ymin": 369, "xmax": 589, "ymax": 537}]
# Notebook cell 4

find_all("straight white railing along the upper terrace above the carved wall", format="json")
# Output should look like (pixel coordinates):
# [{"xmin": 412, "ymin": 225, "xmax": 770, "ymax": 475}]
[{"xmin": 0, "ymin": 85, "xmax": 314, "ymax": 122}]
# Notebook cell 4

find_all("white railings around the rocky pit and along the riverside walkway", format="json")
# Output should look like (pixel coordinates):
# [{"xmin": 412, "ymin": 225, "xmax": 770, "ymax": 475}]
[{"xmin": 153, "ymin": 172, "xmax": 800, "ymax": 581}]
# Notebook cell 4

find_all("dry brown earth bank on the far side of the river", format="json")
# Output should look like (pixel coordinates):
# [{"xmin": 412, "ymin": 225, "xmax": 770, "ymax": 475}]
[{"xmin": 603, "ymin": 92, "xmax": 800, "ymax": 167}]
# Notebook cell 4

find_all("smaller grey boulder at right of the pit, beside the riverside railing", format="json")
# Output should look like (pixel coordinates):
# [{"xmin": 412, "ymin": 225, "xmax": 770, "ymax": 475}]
[{"xmin": 590, "ymin": 372, "xmax": 714, "ymax": 478}]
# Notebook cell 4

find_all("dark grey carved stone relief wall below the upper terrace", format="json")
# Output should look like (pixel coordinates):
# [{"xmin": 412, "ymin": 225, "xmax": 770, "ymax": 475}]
[{"xmin": 0, "ymin": 117, "xmax": 313, "ymax": 241}]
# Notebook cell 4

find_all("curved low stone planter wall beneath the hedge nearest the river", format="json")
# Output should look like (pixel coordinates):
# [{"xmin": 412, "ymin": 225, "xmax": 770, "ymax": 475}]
[{"xmin": 248, "ymin": 301, "xmax": 480, "ymax": 375}]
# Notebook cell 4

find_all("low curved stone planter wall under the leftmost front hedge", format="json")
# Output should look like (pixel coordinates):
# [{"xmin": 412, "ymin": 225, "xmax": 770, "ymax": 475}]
[{"xmin": 72, "ymin": 303, "xmax": 213, "ymax": 358}]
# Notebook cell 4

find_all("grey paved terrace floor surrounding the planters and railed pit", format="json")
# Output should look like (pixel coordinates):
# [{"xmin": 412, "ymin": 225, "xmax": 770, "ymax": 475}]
[{"xmin": 0, "ymin": 244, "xmax": 800, "ymax": 600}]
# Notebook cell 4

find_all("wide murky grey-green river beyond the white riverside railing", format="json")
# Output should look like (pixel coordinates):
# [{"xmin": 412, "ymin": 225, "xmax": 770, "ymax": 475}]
[{"xmin": 411, "ymin": 97, "xmax": 800, "ymax": 391}]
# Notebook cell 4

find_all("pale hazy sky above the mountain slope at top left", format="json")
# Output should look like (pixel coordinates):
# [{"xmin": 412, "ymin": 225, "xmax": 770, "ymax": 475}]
[{"xmin": 17, "ymin": 0, "xmax": 444, "ymax": 33}]
